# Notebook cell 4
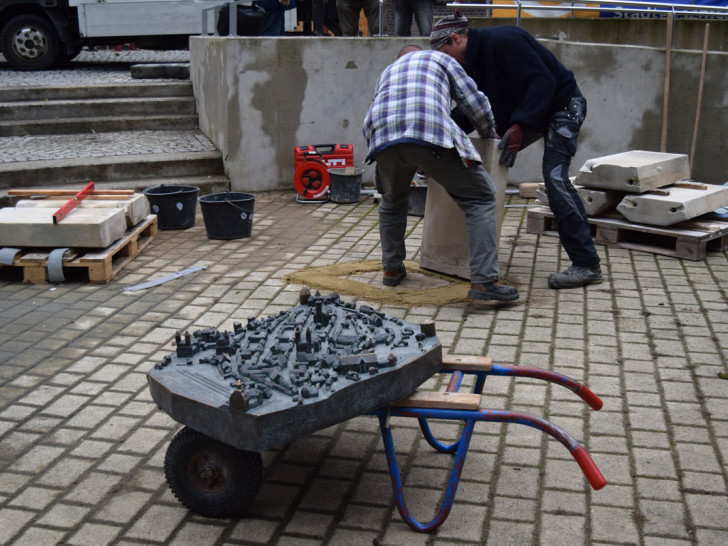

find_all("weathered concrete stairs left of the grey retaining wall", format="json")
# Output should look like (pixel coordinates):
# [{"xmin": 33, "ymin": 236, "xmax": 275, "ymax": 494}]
[{"xmin": 0, "ymin": 81, "xmax": 230, "ymax": 206}]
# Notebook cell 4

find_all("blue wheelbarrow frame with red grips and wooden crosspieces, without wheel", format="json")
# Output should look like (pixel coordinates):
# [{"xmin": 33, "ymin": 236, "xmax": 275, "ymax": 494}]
[{"xmin": 369, "ymin": 356, "xmax": 607, "ymax": 532}]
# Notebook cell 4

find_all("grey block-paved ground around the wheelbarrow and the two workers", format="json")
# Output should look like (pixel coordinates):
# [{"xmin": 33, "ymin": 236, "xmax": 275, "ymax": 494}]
[{"xmin": 0, "ymin": 52, "xmax": 728, "ymax": 546}]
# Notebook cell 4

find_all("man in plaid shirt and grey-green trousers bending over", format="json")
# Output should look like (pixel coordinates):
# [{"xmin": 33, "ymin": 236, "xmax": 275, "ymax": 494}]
[{"xmin": 363, "ymin": 46, "xmax": 518, "ymax": 301}]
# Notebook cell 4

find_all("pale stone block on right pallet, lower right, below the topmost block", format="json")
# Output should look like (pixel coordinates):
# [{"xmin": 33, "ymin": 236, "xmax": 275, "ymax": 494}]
[{"xmin": 617, "ymin": 184, "xmax": 728, "ymax": 226}]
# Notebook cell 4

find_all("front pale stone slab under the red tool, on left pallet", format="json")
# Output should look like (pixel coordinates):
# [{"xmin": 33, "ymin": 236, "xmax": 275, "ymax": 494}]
[{"xmin": 0, "ymin": 207, "xmax": 126, "ymax": 248}]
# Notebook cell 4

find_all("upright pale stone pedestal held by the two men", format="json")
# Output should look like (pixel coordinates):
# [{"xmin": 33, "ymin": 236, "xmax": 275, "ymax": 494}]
[{"xmin": 420, "ymin": 138, "xmax": 508, "ymax": 279}]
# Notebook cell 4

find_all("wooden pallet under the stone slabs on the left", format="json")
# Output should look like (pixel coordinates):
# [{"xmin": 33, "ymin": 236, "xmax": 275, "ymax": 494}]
[{"xmin": 0, "ymin": 214, "xmax": 158, "ymax": 284}]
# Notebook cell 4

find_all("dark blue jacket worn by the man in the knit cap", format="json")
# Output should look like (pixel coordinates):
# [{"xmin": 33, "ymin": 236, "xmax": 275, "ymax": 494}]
[{"xmin": 453, "ymin": 25, "xmax": 580, "ymax": 136}]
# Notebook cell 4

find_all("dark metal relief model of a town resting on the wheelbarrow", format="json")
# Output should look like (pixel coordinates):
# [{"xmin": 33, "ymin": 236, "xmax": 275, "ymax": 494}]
[{"xmin": 147, "ymin": 292, "xmax": 442, "ymax": 452}]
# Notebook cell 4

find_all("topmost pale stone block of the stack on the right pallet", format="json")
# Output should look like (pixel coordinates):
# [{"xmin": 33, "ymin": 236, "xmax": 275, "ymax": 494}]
[{"xmin": 575, "ymin": 150, "xmax": 690, "ymax": 193}]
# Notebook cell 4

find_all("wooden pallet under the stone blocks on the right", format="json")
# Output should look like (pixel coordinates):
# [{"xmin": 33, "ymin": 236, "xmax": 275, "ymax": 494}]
[{"xmin": 526, "ymin": 207, "xmax": 728, "ymax": 260}]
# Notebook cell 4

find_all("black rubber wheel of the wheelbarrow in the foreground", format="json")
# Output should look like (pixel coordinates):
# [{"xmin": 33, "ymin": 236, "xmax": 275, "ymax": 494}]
[{"xmin": 164, "ymin": 427, "xmax": 263, "ymax": 518}]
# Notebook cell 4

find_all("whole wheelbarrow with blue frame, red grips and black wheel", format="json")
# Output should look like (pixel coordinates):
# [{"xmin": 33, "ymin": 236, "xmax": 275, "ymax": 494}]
[{"xmin": 164, "ymin": 348, "xmax": 607, "ymax": 532}]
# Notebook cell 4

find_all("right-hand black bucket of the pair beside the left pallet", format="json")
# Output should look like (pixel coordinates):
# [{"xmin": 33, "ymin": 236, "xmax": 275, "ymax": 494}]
[{"xmin": 200, "ymin": 191, "xmax": 255, "ymax": 239}]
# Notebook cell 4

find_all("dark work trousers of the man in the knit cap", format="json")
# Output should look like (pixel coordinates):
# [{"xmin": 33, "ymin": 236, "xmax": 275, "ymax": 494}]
[{"xmin": 542, "ymin": 96, "xmax": 599, "ymax": 267}]
